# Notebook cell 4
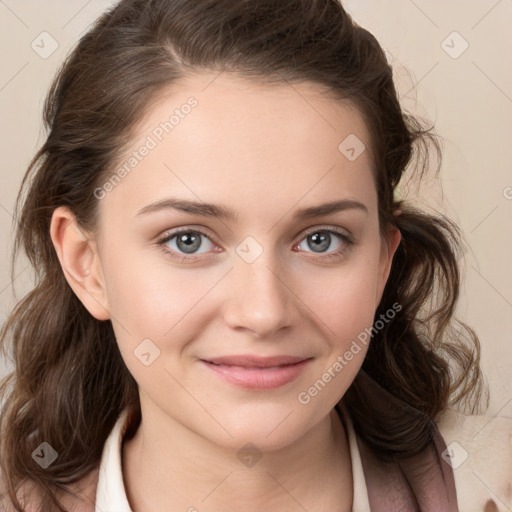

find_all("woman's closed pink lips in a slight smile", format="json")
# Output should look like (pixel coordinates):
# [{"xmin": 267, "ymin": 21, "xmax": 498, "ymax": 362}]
[{"xmin": 201, "ymin": 355, "xmax": 312, "ymax": 389}]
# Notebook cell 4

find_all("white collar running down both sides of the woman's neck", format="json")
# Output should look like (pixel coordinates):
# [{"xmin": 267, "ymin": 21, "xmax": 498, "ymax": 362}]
[{"xmin": 95, "ymin": 407, "xmax": 370, "ymax": 512}]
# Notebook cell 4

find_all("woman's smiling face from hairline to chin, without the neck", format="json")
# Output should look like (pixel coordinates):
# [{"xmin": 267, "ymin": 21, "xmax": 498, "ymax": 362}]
[{"xmin": 67, "ymin": 73, "xmax": 399, "ymax": 449}]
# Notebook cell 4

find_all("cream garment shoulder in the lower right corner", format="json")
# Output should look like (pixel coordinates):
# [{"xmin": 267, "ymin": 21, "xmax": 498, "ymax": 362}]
[{"xmin": 437, "ymin": 409, "xmax": 512, "ymax": 512}]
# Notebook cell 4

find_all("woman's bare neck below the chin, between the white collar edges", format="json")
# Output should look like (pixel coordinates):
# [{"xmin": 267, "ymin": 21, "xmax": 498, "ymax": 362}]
[{"xmin": 123, "ymin": 409, "xmax": 353, "ymax": 512}]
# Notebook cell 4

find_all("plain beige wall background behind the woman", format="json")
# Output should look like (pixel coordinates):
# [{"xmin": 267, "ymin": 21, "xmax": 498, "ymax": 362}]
[{"xmin": 0, "ymin": 0, "xmax": 512, "ymax": 417}]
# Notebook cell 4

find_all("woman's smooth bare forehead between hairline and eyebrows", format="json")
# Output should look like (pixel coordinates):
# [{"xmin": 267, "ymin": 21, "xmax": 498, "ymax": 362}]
[{"xmin": 98, "ymin": 73, "xmax": 374, "ymax": 222}]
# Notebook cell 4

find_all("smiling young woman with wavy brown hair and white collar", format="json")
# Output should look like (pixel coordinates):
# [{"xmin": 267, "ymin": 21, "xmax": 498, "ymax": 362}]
[{"xmin": 0, "ymin": 0, "xmax": 512, "ymax": 512}]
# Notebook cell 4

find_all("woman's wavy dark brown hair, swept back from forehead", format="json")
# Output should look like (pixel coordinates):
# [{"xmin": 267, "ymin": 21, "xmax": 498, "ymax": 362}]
[{"xmin": 0, "ymin": 0, "xmax": 488, "ymax": 511}]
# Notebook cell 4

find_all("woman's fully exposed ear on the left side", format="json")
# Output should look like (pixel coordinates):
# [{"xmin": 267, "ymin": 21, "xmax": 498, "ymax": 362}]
[{"xmin": 50, "ymin": 206, "xmax": 110, "ymax": 320}]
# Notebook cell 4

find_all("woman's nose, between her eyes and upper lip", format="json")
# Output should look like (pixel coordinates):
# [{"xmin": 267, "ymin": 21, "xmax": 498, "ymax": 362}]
[{"xmin": 224, "ymin": 251, "xmax": 300, "ymax": 339}]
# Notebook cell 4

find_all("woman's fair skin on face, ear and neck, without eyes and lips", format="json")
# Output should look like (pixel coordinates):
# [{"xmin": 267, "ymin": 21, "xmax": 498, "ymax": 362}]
[{"xmin": 51, "ymin": 73, "xmax": 400, "ymax": 512}]
